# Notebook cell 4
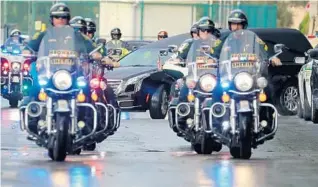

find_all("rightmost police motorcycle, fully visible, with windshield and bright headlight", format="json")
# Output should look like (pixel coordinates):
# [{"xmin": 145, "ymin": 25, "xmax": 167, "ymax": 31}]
[{"xmin": 202, "ymin": 30, "xmax": 284, "ymax": 159}]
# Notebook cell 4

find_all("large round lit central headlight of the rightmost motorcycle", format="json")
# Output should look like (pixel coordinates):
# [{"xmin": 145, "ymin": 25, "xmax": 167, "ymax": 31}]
[{"xmin": 234, "ymin": 72, "xmax": 253, "ymax": 92}]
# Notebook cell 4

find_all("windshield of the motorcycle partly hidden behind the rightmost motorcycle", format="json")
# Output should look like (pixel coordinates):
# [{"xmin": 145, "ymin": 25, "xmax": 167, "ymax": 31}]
[{"xmin": 186, "ymin": 36, "xmax": 217, "ymax": 77}]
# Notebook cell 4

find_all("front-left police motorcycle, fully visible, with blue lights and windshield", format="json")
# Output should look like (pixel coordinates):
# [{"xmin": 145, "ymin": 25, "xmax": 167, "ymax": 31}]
[{"xmin": 20, "ymin": 26, "xmax": 107, "ymax": 161}]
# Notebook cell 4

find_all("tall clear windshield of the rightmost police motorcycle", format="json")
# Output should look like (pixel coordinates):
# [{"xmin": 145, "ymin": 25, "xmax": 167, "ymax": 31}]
[{"xmin": 219, "ymin": 30, "xmax": 268, "ymax": 81}]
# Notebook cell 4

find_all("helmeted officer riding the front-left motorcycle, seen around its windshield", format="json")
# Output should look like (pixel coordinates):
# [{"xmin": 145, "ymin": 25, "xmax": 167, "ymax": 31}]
[{"xmin": 20, "ymin": 3, "xmax": 102, "ymax": 140}]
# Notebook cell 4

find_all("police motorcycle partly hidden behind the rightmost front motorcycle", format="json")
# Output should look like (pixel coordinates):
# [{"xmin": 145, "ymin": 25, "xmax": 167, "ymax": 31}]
[{"xmin": 168, "ymin": 37, "xmax": 222, "ymax": 154}]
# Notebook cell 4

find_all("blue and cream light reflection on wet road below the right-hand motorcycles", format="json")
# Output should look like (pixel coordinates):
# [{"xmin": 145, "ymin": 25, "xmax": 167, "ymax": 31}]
[{"xmin": 197, "ymin": 156, "xmax": 266, "ymax": 187}]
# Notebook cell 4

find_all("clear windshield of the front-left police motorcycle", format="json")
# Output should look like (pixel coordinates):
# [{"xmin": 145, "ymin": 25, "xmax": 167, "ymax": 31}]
[{"xmin": 36, "ymin": 26, "xmax": 88, "ymax": 78}]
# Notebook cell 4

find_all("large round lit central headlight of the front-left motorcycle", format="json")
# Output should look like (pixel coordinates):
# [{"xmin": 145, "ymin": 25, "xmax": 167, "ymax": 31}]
[{"xmin": 52, "ymin": 70, "xmax": 72, "ymax": 90}]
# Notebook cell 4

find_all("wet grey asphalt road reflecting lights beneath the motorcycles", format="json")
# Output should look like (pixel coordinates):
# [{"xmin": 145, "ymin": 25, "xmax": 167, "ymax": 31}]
[{"xmin": 1, "ymin": 100, "xmax": 318, "ymax": 187}]
